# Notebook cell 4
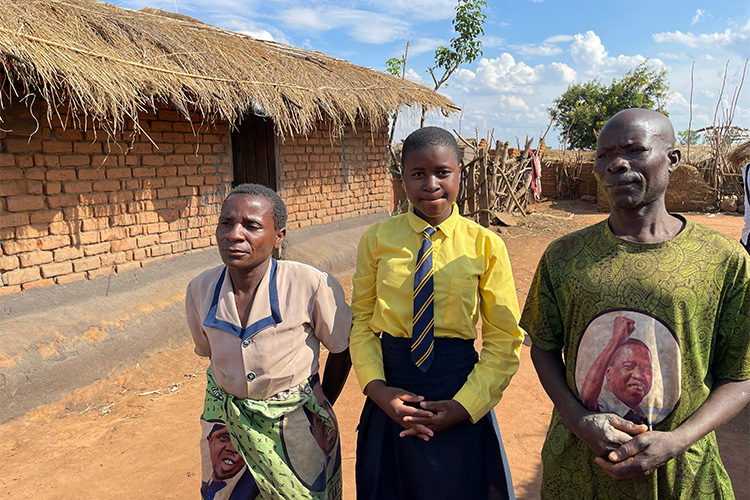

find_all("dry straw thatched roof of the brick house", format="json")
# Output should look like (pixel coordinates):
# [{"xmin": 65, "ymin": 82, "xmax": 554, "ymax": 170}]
[{"xmin": 0, "ymin": 0, "xmax": 454, "ymax": 138}]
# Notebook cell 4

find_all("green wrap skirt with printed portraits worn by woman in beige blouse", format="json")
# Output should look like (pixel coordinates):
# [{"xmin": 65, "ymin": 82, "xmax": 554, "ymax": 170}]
[{"xmin": 201, "ymin": 368, "xmax": 342, "ymax": 500}]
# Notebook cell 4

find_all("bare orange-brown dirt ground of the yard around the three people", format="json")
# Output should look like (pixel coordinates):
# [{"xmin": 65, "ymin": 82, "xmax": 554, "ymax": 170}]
[{"xmin": 0, "ymin": 202, "xmax": 750, "ymax": 500}]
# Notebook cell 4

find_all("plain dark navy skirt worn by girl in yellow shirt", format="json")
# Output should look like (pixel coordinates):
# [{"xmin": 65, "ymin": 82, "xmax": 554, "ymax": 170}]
[{"xmin": 356, "ymin": 333, "xmax": 515, "ymax": 500}]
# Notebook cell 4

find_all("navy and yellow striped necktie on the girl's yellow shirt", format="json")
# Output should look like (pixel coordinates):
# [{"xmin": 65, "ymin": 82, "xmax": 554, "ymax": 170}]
[{"xmin": 411, "ymin": 227, "xmax": 435, "ymax": 372}]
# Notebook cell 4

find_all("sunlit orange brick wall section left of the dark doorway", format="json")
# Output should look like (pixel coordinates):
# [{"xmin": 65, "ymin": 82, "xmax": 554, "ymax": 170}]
[{"xmin": 0, "ymin": 104, "xmax": 232, "ymax": 294}]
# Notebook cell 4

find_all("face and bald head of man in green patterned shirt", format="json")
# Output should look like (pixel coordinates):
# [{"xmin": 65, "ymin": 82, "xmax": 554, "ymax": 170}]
[{"xmin": 594, "ymin": 110, "xmax": 680, "ymax": 210}]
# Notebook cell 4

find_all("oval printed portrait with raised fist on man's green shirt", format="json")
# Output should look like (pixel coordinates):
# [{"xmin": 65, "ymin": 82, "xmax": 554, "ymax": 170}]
[{"xmin": 575, "ymin": 309, "xmax": 682, "ymax": 426}]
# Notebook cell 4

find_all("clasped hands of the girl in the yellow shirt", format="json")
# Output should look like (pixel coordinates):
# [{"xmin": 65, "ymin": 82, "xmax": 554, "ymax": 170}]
[{"xmin": 365, "ymin": 380, "xmax": 469, "ymax": 441}]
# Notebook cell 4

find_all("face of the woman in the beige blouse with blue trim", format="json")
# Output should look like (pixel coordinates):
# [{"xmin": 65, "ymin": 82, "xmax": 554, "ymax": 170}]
[{"xmin": 216, "ymin": 194, "xmax": 286, "ymax": 270}]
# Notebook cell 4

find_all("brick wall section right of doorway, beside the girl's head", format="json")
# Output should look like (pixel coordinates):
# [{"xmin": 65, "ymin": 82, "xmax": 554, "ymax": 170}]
[{"xmin": 279, "ymin": 124, "xmax": 391, "ymax": 229}]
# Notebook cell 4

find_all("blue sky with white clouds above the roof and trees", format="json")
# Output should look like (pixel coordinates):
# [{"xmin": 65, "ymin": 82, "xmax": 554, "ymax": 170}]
[{"xmin": 112, "ymin": 0, "xmax": 750, "ymax": 146}]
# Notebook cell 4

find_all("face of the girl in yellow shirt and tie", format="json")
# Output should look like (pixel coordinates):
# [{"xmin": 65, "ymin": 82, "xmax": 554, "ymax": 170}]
[{"xmin": 404, "ymin": 145, "xmax": 460, "ymax": 227}]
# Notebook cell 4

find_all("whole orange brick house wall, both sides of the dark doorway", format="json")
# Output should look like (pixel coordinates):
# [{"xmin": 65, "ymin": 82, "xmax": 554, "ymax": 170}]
[{"xmin": 0, "ymin": 104, "xmax": 391, "ymax": 295}]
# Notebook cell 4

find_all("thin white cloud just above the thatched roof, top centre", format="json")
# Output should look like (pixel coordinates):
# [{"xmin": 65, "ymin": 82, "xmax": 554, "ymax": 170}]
[{"xmin": 280, "ymin": 7, "xmax": 409, "ymax": 44}]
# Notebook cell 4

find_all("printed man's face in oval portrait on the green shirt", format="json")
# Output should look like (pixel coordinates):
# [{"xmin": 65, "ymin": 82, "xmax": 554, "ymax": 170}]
[{"xmin": 606, "ymin": 344, "xmax": 652, "ymax": 409}]
